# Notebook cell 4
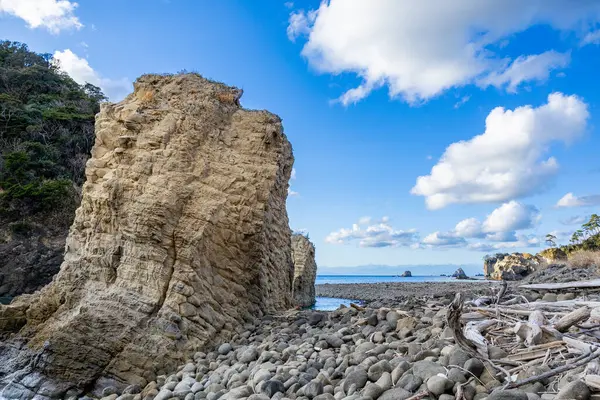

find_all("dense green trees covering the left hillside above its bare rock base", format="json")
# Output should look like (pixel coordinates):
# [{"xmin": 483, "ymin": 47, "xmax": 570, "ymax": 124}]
[{"xmin": 0, "ymin": 41, "xmax": 106, "ymax": 228}]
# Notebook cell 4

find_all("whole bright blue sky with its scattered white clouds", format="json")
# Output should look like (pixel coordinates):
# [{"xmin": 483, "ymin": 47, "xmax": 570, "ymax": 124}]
[{"xmin": 0, "ymin": 0, "xmax": 600, "ymax": 266}]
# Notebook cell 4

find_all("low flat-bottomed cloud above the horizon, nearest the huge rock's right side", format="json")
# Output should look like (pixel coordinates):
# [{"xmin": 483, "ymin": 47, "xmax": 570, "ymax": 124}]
[{"xmin": 325, "ymin": 217, "xmax": 418, "ymax": 247}]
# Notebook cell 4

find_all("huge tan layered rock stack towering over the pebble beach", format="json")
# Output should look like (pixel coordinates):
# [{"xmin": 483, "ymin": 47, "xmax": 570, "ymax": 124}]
[{"xmin": 0, "ymin": 74, "xmax": 293, "ymax": 398}]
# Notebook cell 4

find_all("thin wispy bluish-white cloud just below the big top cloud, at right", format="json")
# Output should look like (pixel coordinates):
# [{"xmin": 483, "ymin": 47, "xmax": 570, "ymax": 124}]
[{"xmin": 479, "ymin": 50, "xmax": 571, "ymax": 93}]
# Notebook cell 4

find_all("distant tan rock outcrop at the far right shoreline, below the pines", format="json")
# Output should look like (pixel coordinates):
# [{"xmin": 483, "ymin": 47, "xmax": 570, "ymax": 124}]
[{"xmin": 484, "ymin": 253, "xmax": 544, "ymax": 281}]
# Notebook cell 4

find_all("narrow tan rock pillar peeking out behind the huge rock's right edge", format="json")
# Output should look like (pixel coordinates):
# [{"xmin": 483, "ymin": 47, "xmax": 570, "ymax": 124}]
[{"xmin": 292, "ymin": 234, "xmax": 317, "ymax": 307}]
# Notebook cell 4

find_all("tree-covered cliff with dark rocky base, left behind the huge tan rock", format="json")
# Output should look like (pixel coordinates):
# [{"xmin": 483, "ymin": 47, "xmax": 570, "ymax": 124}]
[{"xmin": 0, "ymin": 41, "xmax": 106, "ymax": 297}]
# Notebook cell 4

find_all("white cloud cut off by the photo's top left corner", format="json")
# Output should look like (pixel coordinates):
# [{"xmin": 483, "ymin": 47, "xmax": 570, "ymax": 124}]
[{"xmin": 0, "ymin": 0, "xmax": 83, "ymax": 34}]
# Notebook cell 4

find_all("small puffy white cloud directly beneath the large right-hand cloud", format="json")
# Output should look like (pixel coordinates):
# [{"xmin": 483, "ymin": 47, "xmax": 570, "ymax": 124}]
[{"xmin": 483, "ymin": 200, "xmax": 540, "ymax": 233}]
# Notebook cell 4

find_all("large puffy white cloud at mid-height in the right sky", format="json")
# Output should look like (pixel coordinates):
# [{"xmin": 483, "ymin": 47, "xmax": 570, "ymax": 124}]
[{"xmin": 411, "ymin": 93, "xmax": 589, "ymax": 209}]
